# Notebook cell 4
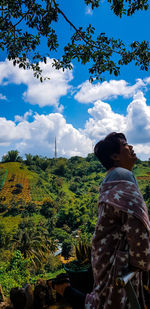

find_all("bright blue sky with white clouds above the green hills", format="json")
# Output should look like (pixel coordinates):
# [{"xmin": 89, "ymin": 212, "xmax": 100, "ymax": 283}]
[{"xmin": 0, "ymin": 0, "xmax": 150, "ymax": 160}]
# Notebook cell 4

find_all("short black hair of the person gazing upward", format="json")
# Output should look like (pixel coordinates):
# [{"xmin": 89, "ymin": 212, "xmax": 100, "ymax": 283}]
[{"xmin": 94, "ymin": 132, "xmax": 126, "ymax": 170}]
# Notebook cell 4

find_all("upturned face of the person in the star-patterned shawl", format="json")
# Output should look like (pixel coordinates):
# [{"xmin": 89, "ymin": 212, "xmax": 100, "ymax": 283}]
[{"xmin": 114, "ymin": 139, "xmax": 137, "ymax": 171}]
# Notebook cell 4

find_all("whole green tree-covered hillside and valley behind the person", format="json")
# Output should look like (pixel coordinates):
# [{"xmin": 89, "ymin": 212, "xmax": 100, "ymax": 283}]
[{"xmin": 0, "ymin": 150, "xmax": 150, "ymax": 295}]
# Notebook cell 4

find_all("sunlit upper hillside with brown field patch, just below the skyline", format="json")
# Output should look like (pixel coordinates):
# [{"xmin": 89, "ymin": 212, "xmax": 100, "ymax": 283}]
[{"xmin": 0, "ymin": 154, "xmax": 150, "ymax": 208}]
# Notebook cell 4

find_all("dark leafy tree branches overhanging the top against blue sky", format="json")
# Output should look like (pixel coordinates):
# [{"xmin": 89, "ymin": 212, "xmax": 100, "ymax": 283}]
[{"xmin": 0, "ymin": 0, "xmax": 150, "ymax": 81}]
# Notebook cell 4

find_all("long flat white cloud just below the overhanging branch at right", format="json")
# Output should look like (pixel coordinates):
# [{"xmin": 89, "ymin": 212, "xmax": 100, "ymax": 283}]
[{"xmin": 74, "ymin": 79, "xmax": 145, "ymax": 103}]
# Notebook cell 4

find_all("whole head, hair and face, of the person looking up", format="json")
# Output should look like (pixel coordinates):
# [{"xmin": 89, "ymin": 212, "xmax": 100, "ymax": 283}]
[{"xmin": 94, "ymin": 132, "xmax": 137, "ymax": 170}]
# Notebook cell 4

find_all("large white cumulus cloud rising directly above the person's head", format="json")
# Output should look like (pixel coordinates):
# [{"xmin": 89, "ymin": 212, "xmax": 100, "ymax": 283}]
[{"xmin": 82, "ymin": 92, "xmax": 150, "ymax": 160}]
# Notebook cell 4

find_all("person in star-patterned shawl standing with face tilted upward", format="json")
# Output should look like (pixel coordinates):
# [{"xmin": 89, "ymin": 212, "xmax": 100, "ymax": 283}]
[{"xmin": 56, "ymin": 132, "xmax": 150, "ymax": 309}]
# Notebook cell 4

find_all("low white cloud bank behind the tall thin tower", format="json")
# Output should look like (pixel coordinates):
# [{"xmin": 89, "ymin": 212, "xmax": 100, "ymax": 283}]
[{"xmin": 0, "ymin": 113, "xmax": 92, "ymax": 157}]
